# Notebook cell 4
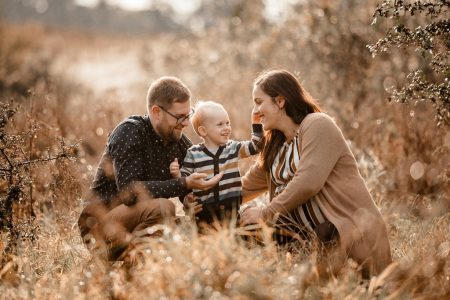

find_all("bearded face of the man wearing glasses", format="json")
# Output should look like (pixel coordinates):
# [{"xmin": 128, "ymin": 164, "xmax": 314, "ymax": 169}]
[{"xmin": 153, "ymin": 101, "xmax": 191, "ymax": 142}]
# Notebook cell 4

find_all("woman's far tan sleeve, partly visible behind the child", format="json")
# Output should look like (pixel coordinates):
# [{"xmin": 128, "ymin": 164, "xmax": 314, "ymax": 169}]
[{"xmin": 242, "ymin": 162, "xmax": 268, "ymax": 203}]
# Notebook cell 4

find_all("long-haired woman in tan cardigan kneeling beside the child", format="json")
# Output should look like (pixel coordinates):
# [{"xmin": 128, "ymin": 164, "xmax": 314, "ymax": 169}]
[{"xmin": 241, "ymin": 70, "xmax": 391, "ymax": 276}]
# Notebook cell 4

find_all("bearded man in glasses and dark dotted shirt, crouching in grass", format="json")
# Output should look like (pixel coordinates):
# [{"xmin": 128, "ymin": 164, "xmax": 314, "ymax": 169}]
[{"xmin": 78, "ymin": 77, "xmax": 222, "ymax": 260}]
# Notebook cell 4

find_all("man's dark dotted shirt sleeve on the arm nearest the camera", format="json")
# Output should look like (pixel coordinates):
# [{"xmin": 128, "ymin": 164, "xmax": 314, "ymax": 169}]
[{"xmin": 109, "ymin": 123, "xmax": 187, "ymax": 202}]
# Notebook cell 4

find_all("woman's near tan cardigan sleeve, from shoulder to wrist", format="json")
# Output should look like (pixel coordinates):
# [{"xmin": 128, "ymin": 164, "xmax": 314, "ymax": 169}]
[{"xmin": 263, "ymin": 116, "xmax": 345, "ymax": 220}]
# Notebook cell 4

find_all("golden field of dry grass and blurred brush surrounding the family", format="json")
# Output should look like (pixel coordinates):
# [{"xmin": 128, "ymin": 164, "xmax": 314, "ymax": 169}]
[{"xmin": 0, "ymin": 1, "xmax": 450, "ymax": 299}]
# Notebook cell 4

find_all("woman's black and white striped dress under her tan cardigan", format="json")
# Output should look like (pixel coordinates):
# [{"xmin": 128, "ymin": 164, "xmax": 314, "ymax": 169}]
[{"xmin": 270, "ymin": 131, "xmax": 327, "ymax": 232}]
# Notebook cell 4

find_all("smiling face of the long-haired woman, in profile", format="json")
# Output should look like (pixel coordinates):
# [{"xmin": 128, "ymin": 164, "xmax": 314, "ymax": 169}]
[{"xmin": 252, "ymin": 85, "xmax": 282, "ymax": 130}]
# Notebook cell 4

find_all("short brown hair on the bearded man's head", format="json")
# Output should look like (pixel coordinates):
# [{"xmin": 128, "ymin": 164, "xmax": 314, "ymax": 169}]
[{"xmin": 147, "ymin": 76, "xmax": 191, "ymax": 111}]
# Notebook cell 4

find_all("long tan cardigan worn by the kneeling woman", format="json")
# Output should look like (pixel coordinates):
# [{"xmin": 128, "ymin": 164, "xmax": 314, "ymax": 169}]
[{"xmin": 242, "ymin": 113, "xmax": 391, "ymax": 274}]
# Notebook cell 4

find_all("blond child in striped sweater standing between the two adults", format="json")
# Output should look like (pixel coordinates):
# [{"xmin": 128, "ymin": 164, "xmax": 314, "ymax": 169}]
[{"xmin": 170, "ymin": 101, "xmax": 263, "ymax": 223}]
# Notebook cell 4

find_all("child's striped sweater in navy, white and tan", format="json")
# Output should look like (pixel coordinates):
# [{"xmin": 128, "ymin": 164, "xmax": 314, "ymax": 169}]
[{"xmin": 181, "ymin": 124, "xmax": 263, "ymax": 209}]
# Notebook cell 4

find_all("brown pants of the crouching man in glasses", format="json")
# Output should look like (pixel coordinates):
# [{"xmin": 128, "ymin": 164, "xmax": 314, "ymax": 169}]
[{"xmin": 78, "ymin": 198, "xmax": 175, "ymax": 260}]
